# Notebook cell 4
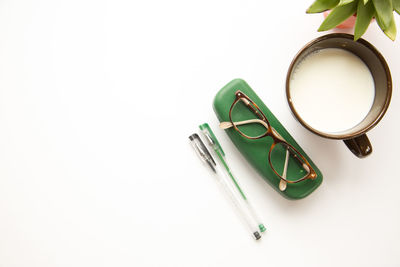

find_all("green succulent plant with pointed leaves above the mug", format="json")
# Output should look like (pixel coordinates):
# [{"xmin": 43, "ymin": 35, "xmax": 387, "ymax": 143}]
[{"xmin": 307, "ymin": 0, "xmax": 400, "ymax": 41}]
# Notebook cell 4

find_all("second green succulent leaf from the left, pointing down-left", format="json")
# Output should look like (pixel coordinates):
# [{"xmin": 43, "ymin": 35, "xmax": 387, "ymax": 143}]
[{"xmin": 318, "ymin": 2, "xmax": 357, "ymax": 32}]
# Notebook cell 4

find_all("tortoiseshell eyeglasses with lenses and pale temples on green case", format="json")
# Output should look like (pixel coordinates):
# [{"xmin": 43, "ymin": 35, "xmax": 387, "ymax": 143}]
[{"xmin": 220, "ymin": 91, "xmax": 317, "ymax": 191}]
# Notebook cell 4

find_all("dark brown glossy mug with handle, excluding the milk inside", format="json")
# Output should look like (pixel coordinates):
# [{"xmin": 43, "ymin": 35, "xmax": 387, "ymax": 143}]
[{"xmin": 286, "ymin": 33, "xmax": 392, "ymax": 158}]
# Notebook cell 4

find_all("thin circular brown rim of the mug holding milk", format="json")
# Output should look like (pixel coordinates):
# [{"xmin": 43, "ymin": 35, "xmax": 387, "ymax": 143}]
[{"xmin": 286, "ymin": 33, "xmax": 392, "ymax": 140}]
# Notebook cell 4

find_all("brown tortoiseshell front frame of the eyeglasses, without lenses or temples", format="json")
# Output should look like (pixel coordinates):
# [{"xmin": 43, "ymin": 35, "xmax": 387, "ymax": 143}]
[{"xmin": 229, "ymin": 91, "xmax": 317, "ymax": 184}]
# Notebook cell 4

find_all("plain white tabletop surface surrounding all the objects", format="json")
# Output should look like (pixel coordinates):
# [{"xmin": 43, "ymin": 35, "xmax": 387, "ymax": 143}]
[{"xmin": 0, "ymin": 0, "xmax": 400, "ymax": 267}]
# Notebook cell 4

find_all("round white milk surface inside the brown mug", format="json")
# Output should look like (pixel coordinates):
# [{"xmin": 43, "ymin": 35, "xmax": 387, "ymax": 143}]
[{"xmin": 290, "ymin": 48, "xmax": 375, "ymax": 133}]
